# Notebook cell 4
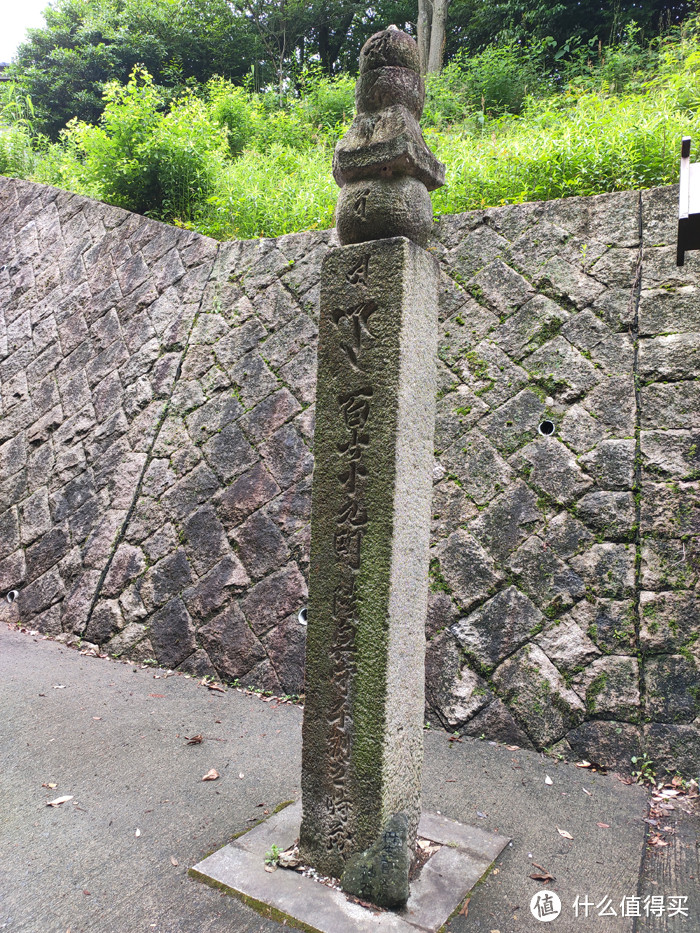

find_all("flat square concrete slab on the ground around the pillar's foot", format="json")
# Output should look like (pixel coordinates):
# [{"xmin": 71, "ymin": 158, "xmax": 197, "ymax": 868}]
[{"xmin": 190, "ymin": 803, "xmax": 510, "ymax": 933}]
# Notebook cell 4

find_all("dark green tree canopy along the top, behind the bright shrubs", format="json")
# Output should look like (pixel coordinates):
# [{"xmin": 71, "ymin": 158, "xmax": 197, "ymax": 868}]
[{"xmin": 10, "ymin": 0, "xmax": 694, "ymax": 138}]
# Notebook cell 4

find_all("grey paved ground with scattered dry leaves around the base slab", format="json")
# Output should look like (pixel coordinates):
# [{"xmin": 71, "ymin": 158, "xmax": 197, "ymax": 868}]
[{"xmin": 0, "ymin": 624, "xmax": 700, "ymax": 933}]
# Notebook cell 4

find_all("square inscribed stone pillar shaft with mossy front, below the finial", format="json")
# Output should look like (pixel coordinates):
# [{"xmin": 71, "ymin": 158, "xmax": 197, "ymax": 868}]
[{"xmin": 300, "ymin": 237, "xmax": 438, "ymax": 896}]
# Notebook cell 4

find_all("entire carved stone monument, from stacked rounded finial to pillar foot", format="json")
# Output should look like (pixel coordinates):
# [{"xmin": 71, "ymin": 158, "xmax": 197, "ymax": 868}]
[{"xmin": 299, "ymin": 27, "xmax": 444, "ymax": 906}]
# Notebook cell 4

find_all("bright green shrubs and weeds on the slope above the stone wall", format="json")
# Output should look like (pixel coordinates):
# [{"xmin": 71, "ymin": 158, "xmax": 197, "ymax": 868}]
[{"xmin": 0, "ymin": 6, "xmax": 700, "ymax": 238}]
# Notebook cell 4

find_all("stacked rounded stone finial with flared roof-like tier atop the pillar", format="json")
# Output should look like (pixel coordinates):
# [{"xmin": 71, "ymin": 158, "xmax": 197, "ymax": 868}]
[{"xmin": 333, "ymin": 26, "xmax": 445, "ymax": 246}]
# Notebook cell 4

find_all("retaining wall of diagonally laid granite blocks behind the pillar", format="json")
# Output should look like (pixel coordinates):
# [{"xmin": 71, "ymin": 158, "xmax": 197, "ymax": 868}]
[{"xmin": 0, "ymin": 179, "xmax": 700, "ymax": 773}]
